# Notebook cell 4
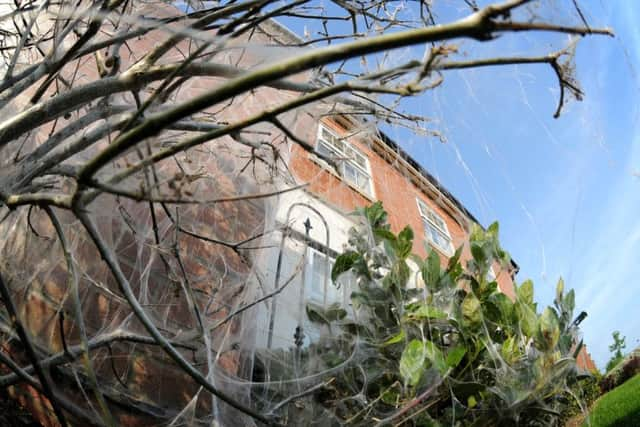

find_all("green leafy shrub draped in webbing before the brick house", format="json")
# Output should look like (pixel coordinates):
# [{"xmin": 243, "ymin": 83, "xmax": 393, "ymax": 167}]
[{"xmin": 292, "ymin": 203, "xmax": 592, "ymax": 426}]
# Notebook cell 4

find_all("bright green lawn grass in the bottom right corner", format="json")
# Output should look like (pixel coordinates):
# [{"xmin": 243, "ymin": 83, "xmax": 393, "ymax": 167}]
[{"xmin": 582, "ymin": 374, "xmax": 640, "ymax": 427}]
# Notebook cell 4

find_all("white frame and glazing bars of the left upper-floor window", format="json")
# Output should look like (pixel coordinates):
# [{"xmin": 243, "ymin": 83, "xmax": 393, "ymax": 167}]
[{"xmin": 316, "ymin": 124, "xmax": 374, "ymax": 198}]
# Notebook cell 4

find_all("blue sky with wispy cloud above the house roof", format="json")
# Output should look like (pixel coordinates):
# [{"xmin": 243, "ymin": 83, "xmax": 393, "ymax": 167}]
[{"xmin": 286, "ymin": 0, "xmax": 640, "ymax": 368}]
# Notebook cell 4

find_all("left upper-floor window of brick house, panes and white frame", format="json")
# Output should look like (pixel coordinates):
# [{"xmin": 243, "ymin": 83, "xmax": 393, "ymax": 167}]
[{"xmin": 316, "ymin": 125, "xmax": 373, "ymax": 196}]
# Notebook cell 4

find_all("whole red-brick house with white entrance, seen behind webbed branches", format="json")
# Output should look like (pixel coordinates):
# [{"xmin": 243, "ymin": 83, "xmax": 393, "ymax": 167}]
[{"xmin": 0, "ymin": 8, "xmax": 590, "ymax": 426}]
